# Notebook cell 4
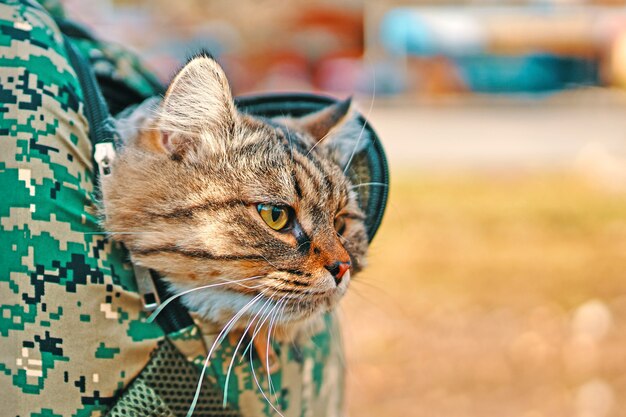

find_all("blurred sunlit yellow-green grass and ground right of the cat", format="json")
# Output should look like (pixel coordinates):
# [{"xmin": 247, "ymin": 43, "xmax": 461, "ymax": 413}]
[{"xmin": 343, "ymin": 172, "xmax": 626, "ymax": 417}]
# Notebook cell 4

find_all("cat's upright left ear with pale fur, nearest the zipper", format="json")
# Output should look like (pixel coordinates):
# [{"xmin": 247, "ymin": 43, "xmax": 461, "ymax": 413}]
[{"xmin": 150, "ymin": 55, "xmax": 237, "ymax": 153}]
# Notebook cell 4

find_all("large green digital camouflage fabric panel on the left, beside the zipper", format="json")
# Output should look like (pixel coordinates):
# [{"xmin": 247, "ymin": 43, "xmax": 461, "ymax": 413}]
[{"xmin": 0, "ymin": 1, "xmax": 162, "ymax": 417}]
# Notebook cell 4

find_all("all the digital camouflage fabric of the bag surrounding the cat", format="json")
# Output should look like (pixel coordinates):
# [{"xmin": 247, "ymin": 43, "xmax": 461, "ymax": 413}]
[{"xmin": 0, "ymin": 0, "xmax": 343, "ymax": 417}]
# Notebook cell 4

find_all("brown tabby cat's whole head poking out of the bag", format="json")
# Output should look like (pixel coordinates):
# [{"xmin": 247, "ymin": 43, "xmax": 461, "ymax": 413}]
[{"xmin": 102, "ymin": 56, "xmax": 368, "ymax": 322}]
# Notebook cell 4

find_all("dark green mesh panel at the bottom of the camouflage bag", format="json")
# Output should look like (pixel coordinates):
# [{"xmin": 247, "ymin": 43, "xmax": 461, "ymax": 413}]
[{"xmin": 107, "ymin": 341, "xmax": 239, "ymax": 417}]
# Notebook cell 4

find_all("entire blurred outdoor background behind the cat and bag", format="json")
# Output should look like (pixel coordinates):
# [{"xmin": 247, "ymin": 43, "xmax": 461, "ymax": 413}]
[{"xmin": 65, "ymin": 0, "xmax": 626, "ymax": 417}]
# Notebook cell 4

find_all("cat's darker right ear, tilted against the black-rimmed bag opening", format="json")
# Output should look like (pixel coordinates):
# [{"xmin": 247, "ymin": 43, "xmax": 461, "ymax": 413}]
[{"xmin": 299, "ymin": 98, "xmax": 371, "ymax": 168}]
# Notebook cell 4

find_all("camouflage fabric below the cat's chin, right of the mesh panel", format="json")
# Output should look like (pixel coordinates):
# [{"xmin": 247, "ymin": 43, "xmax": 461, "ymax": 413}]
[{"xmin": 193, "ymin": 315, "xmax": 344, "ymax": 417}]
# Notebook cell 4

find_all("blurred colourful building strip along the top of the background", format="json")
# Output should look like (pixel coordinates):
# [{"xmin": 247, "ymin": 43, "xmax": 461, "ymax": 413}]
[{"xmin": 61, "ymin": 0, "xmax": 626, "ymax": 97}]
